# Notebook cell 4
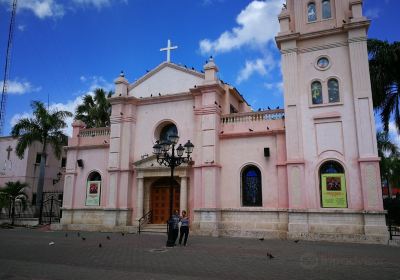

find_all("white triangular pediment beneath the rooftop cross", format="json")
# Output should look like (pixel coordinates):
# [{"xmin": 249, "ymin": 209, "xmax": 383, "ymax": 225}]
[{"xmin": 129, "ymin": 62, "xmax": 204, "ymax": 98}]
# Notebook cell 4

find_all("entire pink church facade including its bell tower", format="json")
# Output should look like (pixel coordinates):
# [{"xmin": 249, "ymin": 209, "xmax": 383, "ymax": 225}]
[{"xmin": 61, "ymin": 0, "xmax": 388, "ymax": 243}]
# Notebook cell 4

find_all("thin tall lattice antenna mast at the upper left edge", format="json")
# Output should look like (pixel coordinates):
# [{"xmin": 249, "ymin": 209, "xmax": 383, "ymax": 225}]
[{"xmin": 0, "ymin": 0, "xmax": 17, "ymax": 135}]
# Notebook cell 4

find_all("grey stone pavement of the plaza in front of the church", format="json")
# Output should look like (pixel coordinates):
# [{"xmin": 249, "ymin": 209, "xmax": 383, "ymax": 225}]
[{"xmin": 0, "ymin": 228, "xmax": 400, "ymax": 280}]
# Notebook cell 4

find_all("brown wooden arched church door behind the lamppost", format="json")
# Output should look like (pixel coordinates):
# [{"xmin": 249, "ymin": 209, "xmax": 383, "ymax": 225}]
[{"xmin": 150, "ymin": 177, "xmax": 180, "ymax": 224}]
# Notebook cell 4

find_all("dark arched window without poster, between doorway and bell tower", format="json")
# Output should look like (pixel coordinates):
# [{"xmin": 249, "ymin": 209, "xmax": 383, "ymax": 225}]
[{"xmin": 242, "ymin": 165, "xmax": 262, "ymax": 206}]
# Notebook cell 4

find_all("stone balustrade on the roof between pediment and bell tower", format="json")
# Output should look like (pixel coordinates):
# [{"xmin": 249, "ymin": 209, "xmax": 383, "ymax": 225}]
[{"xmin": 221, "ymin": 109, "xmax": 285, "ymax": 124}]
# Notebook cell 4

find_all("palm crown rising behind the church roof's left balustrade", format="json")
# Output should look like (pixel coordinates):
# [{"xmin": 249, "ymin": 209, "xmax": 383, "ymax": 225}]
[{"xmin": 75, "ymin": 88, "xmax": 112, "ymax": 128}]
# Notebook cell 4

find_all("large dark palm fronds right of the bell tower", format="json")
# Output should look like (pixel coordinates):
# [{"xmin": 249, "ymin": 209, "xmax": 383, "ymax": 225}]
[{"xmin": 368, "ymin": 39, "xmax": 400, "ymax": 131}]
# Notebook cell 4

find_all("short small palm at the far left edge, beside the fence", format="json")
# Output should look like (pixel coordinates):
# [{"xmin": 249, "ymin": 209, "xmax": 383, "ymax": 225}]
[{"xmin": 0, "ymin": 181, "xmax": 28, "ymax": 225}]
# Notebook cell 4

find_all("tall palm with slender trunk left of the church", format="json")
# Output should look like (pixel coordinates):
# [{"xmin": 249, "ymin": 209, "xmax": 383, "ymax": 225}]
[{"xmin": 11, "ymin": 101, "xmax": 72, "ymax": 223}]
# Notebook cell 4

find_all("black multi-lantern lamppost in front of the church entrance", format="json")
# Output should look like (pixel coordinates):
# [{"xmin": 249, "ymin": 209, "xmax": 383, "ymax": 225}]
[{"xmin": 153, "ymin": 134, "xmax": 194, "ymax": 247}]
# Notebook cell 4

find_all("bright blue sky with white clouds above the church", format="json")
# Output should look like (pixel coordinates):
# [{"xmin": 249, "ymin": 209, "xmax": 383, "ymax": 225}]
[{"xmin": 0, "ymin": 0, "xmax": 400, "ymax": 140}]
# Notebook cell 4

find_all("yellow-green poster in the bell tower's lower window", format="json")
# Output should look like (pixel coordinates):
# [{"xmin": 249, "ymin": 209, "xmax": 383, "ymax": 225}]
[{"xmin": 321, "ymin": 173, "xmax": 347, "ymax": 208}]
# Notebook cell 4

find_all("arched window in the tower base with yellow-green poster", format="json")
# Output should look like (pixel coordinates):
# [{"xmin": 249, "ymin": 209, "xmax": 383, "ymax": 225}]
[{"xmin": 319, "ymin": 161, "xmax": 347, "ymax": 208}]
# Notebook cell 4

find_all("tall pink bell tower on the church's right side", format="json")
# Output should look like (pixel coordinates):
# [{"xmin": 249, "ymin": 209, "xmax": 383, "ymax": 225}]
[{"xmin": 276, "ymin": 0, "xmax": 387, "ymax": 240}]
